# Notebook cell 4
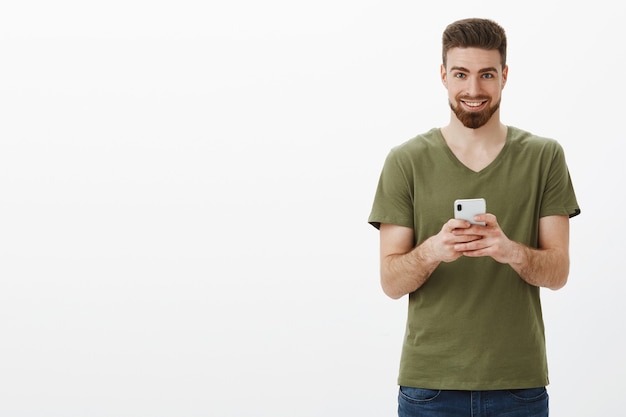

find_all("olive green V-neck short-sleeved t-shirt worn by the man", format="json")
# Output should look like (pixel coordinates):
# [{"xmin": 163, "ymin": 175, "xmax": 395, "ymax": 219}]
[{"xmin": 368, "ymin": 126, "xmax": 580, "ymax": 390}]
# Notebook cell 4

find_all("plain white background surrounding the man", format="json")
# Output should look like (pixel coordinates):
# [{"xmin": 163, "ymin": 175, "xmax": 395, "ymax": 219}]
[{"xmin": 0, "ymin": 0, "xmax": 626, "ymax": 417}]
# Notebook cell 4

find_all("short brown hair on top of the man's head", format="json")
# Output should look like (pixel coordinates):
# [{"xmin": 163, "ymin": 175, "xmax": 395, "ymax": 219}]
[{"xmin": 442, "ymin": 18, "xmax": 506, "ymax": 68}]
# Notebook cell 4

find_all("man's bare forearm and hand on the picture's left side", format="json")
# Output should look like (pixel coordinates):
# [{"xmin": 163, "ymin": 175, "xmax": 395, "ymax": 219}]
[{"xmin": 380, "ymin": 219, "xmax": 477, "ymax": 299}]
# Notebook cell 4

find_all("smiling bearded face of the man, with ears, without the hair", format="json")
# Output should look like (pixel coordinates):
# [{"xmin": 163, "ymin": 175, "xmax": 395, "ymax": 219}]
[{"xmin": 441, "ymin": 48, "xmax": 508, "ymax": 129}]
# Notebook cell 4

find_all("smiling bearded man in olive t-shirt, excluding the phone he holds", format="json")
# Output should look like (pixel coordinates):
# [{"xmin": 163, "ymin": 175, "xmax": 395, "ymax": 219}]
[{"xmin": 369, "ymin": 19, "xmax": 580, "ymax": 417}]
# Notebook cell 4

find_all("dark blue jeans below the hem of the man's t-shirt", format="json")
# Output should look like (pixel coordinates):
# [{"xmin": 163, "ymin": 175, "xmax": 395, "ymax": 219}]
[{"xmin": 398, "ymin": 387, "xmax": 548, "ymax": 417}]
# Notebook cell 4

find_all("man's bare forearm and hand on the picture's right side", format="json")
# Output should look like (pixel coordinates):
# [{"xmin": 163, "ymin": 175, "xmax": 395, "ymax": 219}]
[{"xmin": 455, "ymin": 214, "xmax": 570, "ymax": 290}]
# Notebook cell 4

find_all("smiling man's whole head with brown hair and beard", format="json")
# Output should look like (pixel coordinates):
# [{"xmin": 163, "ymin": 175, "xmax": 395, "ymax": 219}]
[{"xmin": 441, "ymin": 19, "xmax": 508, "ymax": 129}]
